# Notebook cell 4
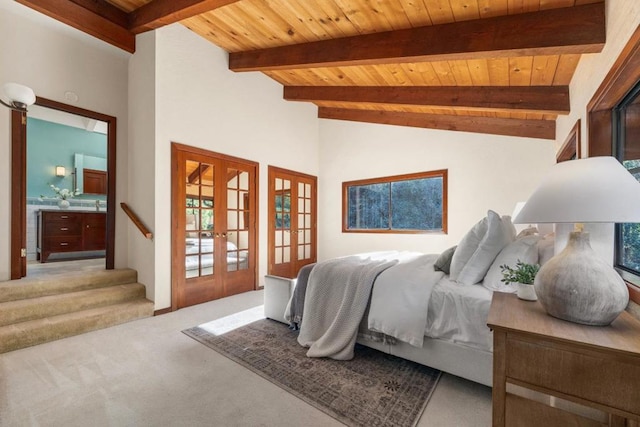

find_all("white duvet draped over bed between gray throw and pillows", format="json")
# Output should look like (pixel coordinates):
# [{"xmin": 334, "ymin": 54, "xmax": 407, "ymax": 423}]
[{"xmin": 367, "ymin": 253, "xmax": 493, "ymax": 351}]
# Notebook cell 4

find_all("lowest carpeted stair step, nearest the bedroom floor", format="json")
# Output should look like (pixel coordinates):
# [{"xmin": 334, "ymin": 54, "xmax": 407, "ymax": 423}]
[{"xmin": 0, "ymin": 298, "xmax": 154, "ymax": 353}]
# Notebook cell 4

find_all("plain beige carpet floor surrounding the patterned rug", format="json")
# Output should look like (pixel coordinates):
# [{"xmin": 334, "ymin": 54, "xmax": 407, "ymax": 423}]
[{"xmin": 0, "ymin": 291, "xmax": 491, "ymax": 427}]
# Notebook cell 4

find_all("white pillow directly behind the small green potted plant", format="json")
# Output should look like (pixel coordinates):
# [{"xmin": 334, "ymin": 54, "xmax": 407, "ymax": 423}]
[{"xmin": 482, "ymin": 236, "xmax": 541, "ymax": 293}]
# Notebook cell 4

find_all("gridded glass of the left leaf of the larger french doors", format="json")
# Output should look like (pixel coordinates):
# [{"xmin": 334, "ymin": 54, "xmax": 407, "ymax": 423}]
[{"xmin": 184, "ymin": 160, "xmax": 214, "ymax": 278}]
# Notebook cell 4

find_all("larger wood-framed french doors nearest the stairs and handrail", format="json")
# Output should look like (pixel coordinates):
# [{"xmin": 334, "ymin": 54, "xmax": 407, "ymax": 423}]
[{"xmin": 172, "ymin": 143, "xmax": 258, "ymax": 310}]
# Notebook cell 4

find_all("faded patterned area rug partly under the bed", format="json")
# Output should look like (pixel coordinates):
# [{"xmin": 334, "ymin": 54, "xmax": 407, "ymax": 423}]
[{"xmin": 183, "ymin": 319, "xmax": 440, "ymax": 426}]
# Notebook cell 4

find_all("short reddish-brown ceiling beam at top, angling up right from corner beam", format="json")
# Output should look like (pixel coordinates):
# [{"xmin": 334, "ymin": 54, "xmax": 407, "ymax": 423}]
[{"xmin": 129, "ymin": 0, "xmax": 238, "ymax": 34}]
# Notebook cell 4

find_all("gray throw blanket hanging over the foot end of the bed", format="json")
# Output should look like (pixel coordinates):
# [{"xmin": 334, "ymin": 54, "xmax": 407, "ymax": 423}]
[{"xmin": 298, "ymin": 256, "xmax": 397, "ymax": 360}]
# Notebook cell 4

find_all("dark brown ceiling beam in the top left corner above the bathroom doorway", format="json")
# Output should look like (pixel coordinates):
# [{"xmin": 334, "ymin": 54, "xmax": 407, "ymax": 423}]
[{"xmin": 16, "ymin": 0, "xmax": 136, "ymax": 53}]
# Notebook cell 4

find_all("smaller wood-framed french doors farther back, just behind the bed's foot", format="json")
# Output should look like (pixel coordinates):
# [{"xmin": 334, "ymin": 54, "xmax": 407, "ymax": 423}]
[{"xmin": 268, "ymin": 166, "xmax": 317, "ymax": 278}]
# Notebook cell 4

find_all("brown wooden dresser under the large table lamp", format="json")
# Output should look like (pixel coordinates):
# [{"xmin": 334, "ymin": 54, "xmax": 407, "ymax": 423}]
[{"xmin": 487, "ymin": 292, "xmax": 640, "ymax": 427}]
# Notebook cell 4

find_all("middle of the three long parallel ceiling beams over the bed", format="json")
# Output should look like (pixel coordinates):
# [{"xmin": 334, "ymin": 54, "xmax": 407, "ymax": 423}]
[{"xmin": 284, "ymin": 86, "xmax": 571, "ymax": 114}]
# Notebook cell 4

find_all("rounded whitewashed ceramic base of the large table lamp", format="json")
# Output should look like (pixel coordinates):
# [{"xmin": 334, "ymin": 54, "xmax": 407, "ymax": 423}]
[{"xmin": 534, "ymin": 232, "xmax": 629, "ymax": 326}]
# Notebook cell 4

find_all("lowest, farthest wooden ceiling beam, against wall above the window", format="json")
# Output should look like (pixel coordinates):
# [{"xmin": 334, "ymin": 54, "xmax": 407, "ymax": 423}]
[{"xmin": 318, "ymin": 107, "xmax": 556, "ymax": 140}]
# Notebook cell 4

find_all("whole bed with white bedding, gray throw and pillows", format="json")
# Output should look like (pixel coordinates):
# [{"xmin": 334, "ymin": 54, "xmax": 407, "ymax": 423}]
[{"xmin": 265, "ymin": 211, "xmax": 553, "ymax": 386}]
